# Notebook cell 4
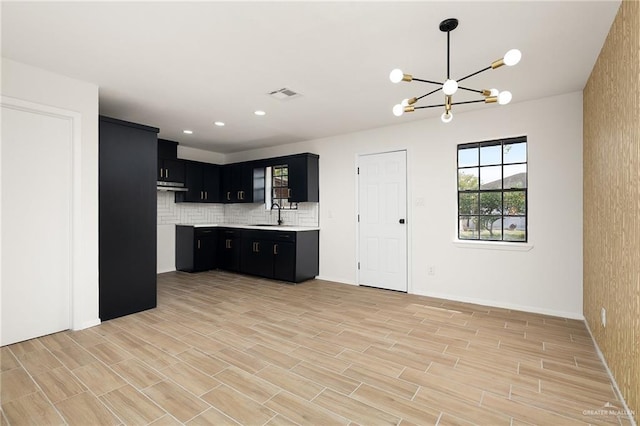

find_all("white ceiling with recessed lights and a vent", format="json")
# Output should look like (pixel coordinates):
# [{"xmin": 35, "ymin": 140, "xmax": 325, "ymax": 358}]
[{"xmin": 2, "ymin": 0, "xmax": 620, "ymax": 153}]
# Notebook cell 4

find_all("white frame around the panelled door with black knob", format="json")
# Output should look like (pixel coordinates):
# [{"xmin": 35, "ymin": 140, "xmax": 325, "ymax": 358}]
[{"xmin": 353, "ymin": 148, "xmax": 413, "ymax": 294}]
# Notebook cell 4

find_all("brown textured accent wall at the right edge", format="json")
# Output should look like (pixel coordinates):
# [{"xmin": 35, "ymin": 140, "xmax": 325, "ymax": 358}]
[{"xmin": 583, "ymin": 0, "xmax": 640, "ymax": 419}]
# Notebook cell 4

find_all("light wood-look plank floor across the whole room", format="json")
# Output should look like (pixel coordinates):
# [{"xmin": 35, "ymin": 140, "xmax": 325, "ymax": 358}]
[{"xmin": 1, "ymin": 272, "xmax": 630, "ymax": 425}]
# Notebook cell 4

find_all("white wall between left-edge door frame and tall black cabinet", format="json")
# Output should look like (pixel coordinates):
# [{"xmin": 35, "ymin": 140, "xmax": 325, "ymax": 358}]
[{"xmin": 1, "ymin": 58, "xmax": 100, "ymax": 329}]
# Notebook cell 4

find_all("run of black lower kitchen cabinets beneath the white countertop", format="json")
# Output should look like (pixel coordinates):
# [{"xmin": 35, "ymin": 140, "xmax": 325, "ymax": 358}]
[{"xmin": 176, "ymin": 225, "xmax": 319, "ymax": 283}]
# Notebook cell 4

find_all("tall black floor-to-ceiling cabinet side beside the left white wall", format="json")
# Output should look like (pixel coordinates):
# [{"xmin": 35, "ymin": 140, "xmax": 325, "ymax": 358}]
[{"xmin": 98, "ymin": 116, "xmax": 158, "ymax": 321}]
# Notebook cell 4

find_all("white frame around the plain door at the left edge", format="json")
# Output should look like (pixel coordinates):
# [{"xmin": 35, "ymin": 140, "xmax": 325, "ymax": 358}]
[{"xmin": 0, "ymin": 96, "xmax": 84, "ymax": 344}]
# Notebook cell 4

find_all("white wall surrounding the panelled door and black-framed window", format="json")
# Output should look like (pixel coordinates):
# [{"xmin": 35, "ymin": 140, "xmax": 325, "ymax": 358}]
[{"xmin": 226, "ymin": 92, "xmax": 582, "ymax": 318}]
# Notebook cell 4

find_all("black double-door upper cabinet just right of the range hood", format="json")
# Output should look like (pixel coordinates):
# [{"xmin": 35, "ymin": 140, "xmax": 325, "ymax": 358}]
[{"xmin": 176, "ymin": 160, "xmax": 221, "ymax": 203}]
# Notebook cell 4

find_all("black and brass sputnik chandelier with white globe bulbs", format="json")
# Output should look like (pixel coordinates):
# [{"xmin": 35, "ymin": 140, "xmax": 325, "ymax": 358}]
[{"xmin": 389, "ymin": 18, "xmax": 522, "ymax": 123}]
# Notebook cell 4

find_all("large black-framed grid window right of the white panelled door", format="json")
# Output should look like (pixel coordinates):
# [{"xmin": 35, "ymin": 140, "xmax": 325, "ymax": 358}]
[{"xmin": 458, "ymin": 136, "xmax": 527, "ymax": 242}]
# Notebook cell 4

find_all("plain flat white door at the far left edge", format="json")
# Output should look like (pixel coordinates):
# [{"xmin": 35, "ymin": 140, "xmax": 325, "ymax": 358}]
[{"xmin": 0, "ymin": 105, "xmax": 73, "ymax": 345}]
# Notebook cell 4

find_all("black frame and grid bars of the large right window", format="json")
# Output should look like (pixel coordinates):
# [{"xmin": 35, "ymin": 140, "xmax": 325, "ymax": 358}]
[{"xmin": 456, "ymin": 136, "xmax": 529, "ymax": 244}]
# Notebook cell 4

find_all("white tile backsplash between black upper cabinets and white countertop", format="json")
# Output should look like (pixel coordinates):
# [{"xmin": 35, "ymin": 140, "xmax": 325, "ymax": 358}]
[{"xmin": 158, "ymin": 191, "xmax": 319, "ymax": 226}]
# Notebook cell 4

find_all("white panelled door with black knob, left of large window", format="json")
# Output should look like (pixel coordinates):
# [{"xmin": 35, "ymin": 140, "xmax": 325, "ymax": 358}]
[{"xmin": 358, "ymin": 151, "xmax": 407, "ymax": 292}]
